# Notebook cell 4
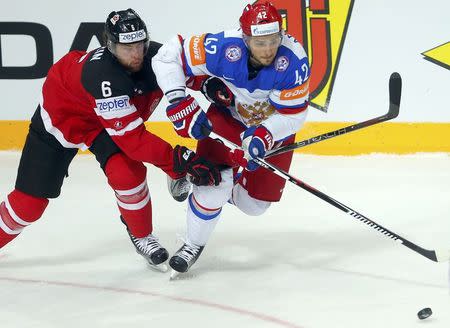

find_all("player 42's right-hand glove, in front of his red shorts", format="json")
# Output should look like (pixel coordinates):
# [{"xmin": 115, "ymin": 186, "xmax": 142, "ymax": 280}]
[{"xmin": 230, "ymin": 125, "xmax": 273, "ymax": 171}]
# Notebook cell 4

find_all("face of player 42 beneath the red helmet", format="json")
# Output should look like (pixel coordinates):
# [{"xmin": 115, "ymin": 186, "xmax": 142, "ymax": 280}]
[{"xmin": 247, "ymin": 33, "xmax": 281, "ymax": 66}]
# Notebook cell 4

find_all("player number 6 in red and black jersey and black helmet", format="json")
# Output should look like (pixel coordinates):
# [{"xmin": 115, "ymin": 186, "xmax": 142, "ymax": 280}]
[{"xmin": 0, "ymin": 9, "xmax": 221, "ymax": 268}]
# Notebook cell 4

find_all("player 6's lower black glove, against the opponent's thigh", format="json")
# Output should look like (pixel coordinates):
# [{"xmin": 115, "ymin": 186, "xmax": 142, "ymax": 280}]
[{"xmin": 173, "ymin": 145, "xmax": 222, "ymax": 186}]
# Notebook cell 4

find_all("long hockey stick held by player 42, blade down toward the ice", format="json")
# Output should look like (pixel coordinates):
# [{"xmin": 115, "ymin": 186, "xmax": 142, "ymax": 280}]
[{"xmin": 209, "ymin": 132, "xmax": 450, "ymax": 262}]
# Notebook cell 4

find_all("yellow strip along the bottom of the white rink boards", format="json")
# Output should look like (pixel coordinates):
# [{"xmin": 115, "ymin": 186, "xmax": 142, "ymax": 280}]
[{"xmin": 0, "ymin": 121, "xmax": 450, "ymax": 155}]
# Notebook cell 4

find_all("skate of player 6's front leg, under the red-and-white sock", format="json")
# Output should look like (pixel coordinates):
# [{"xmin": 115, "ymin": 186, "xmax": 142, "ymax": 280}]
[{"xmin": 128, "ymin": 232, "xmax": 169, "ymax": 272}]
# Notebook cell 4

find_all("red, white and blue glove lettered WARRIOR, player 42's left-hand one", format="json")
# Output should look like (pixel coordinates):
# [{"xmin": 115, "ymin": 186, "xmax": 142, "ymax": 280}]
[{"xmin": 166, "ymin": 95, "xmax": 212, "ymax": 140}]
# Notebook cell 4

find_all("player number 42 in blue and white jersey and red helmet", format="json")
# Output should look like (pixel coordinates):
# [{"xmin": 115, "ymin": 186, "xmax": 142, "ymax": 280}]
[{"xmin": 152, "ymin": 3, "xmax": 310, "ymax": 276}]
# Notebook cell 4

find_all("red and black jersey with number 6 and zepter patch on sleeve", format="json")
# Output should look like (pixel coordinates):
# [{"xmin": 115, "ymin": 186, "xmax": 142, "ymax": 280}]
[{"xmin": 41, "ymin": 42, "xmax": 176, "ymax": 176}]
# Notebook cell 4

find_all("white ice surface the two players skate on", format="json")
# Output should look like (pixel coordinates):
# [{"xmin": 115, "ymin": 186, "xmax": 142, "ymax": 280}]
[{"xmin": 0, "ymin": 152, "xmax": 450, "ymax": 328}]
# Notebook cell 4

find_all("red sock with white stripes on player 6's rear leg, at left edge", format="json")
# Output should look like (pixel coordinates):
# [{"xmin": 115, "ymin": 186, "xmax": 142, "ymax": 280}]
[{"xmin": 0, "ymin": 189, "xmax": 48, "ymax": 248}]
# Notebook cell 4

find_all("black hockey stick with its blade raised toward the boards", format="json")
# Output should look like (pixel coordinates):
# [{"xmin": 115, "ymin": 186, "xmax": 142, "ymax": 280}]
[{"xmin": 266, "ymin": 72, "xmax": 402, "ymax": 158}]
